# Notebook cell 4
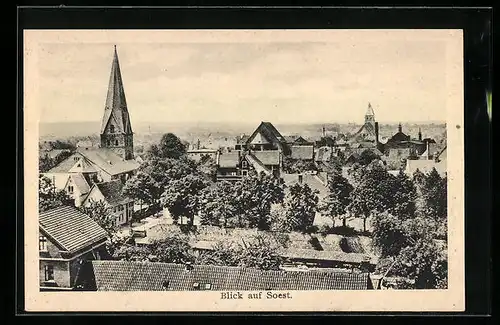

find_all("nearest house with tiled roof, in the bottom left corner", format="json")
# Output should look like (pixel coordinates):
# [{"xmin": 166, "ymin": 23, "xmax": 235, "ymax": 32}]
[{"xmin": 38, "ymin": 206, "xmax": 107, "ymax": 291}]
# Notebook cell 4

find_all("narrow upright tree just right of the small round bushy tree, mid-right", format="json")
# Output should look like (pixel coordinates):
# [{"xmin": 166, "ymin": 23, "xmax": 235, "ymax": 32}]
[{"xmin": 319, "ymin": 173, "xmax": 354, "ymax": 227}]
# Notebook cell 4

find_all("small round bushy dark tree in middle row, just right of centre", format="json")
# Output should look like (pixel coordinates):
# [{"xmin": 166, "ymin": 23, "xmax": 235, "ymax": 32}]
[{"xmin": 285, "ymin": 183, "xmax": 318, "ymax": 232}]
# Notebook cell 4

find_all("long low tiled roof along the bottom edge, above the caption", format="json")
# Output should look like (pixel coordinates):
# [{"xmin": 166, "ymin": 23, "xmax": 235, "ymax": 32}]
[{"xmin": 83, "ymin": 260, "xmax": 371, "ymax": 291}]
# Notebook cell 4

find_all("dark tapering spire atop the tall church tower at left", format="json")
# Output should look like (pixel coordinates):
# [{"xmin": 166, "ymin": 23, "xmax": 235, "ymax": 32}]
[{"xmin": 101, "ymin": 45, "xmax": 132, "ymax": 134}]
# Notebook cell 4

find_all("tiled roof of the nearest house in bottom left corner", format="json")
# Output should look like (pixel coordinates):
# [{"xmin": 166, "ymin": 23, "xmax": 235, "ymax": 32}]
[{"xmin": 39, "ymin": 206, "xmax": 107, "ymax": 253}]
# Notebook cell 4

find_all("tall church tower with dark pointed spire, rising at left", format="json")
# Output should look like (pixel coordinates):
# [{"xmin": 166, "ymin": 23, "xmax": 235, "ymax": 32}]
[{"xmin": 101, "ymin": 45, "xmax": 134, "ymax": 160}]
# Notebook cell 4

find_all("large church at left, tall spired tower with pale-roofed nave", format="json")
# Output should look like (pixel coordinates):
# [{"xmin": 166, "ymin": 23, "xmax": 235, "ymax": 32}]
[{"xmin": 39, "ymin": 47, "xmax": 139, "ymax": 189}]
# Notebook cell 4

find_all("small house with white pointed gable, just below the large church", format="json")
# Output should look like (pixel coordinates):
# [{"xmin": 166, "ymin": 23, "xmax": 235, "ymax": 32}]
[{"xmin": 82, "ymin": 180, "xmax": 134, "ymax": 226}]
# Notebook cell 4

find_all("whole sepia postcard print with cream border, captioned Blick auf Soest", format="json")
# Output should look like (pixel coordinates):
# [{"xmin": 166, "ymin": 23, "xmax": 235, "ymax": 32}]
[{"xmin": 24, "ymin": 30, "xmax": 464, "ymax": 311}]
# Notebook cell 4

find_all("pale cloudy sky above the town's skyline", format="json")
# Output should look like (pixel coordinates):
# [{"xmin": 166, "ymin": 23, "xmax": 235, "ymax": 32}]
[{"xmin": 37, "ymin": 30, "xmax": 447, "ymax": 124}]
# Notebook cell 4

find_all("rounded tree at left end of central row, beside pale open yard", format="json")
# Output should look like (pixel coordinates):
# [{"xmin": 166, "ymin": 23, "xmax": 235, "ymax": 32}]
[{"xmin": 162, "ymin": 174, "xmax": 208, "ymax": 225}]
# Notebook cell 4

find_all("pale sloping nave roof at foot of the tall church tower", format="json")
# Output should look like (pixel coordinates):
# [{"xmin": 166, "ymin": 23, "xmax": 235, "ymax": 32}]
[{"xmin": 78, "ymin": 148, "xmax": 139, "ymax": 175}]
